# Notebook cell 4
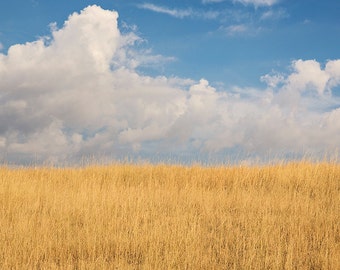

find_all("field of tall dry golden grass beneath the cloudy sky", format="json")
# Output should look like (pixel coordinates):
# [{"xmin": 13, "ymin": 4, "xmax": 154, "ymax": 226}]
[{"xmin": 0, "ymin": 161, "xmax": 340, "ymax": 269}]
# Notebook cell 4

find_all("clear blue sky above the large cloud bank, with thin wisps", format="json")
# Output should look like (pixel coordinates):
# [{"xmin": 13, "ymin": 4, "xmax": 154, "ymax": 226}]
[{"xmin": 0, "ymin": 0, "xmax": 340, "ymax": 86}]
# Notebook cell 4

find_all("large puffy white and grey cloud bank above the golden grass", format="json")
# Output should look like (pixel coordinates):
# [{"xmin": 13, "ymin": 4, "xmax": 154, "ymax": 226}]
[{"xmin": 0, "ymin": 6, "xmax": 340, "ymax": 164}]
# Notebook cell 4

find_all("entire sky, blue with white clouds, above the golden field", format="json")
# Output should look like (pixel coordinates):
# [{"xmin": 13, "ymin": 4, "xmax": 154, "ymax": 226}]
[{"xmin": 0, "ymin": 0, "xmax": 340, "ymax": 165}]
